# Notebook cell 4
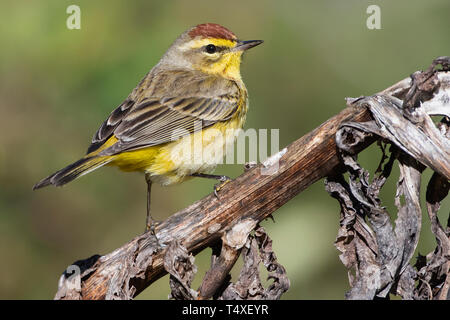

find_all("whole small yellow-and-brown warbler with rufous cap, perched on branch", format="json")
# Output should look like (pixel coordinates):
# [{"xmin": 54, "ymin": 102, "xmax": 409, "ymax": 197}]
[{"xmin": 33, "ymin": 23, "xmax": 263, "ymax": 234}]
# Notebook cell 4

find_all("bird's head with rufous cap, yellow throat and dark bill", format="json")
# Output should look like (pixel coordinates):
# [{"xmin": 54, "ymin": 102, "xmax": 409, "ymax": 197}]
[{"xmin": 161, "ymin": 23, "xmax": 263, "ymax": 79}]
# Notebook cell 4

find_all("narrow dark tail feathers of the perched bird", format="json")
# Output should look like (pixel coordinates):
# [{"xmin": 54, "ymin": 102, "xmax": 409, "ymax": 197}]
[{"xmin": 33, "ymin": 156, "xmax": 112, "ymax": 190}]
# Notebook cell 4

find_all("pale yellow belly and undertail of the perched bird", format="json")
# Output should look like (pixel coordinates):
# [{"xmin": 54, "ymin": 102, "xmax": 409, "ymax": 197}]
[{"xmin": 108, "ymin": 117, "xmax": 244, "ymax": 185}]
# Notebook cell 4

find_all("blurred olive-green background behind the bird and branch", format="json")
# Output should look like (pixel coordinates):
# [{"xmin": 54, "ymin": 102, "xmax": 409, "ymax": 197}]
[{"xmin": 0, "ymin": 0, "xmax": 450, "ymax": 299}]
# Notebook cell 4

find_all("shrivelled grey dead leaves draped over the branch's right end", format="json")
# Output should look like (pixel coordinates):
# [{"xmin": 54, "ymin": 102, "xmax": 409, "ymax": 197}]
[{"xmin": 326, "ymin": 57, "xmax": 450, "ymax": 299}]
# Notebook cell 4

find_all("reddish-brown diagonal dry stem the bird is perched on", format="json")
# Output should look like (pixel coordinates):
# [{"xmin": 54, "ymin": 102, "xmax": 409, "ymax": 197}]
[{"xmin": 55, "ymin": 56, "xmax": 445, "ymax": 299}]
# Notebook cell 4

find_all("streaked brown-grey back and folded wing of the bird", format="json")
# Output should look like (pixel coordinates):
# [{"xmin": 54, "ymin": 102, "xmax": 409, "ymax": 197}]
[{"xmin": 88, "ymin": 71, "xmax": 241, "ymax": 155}]
